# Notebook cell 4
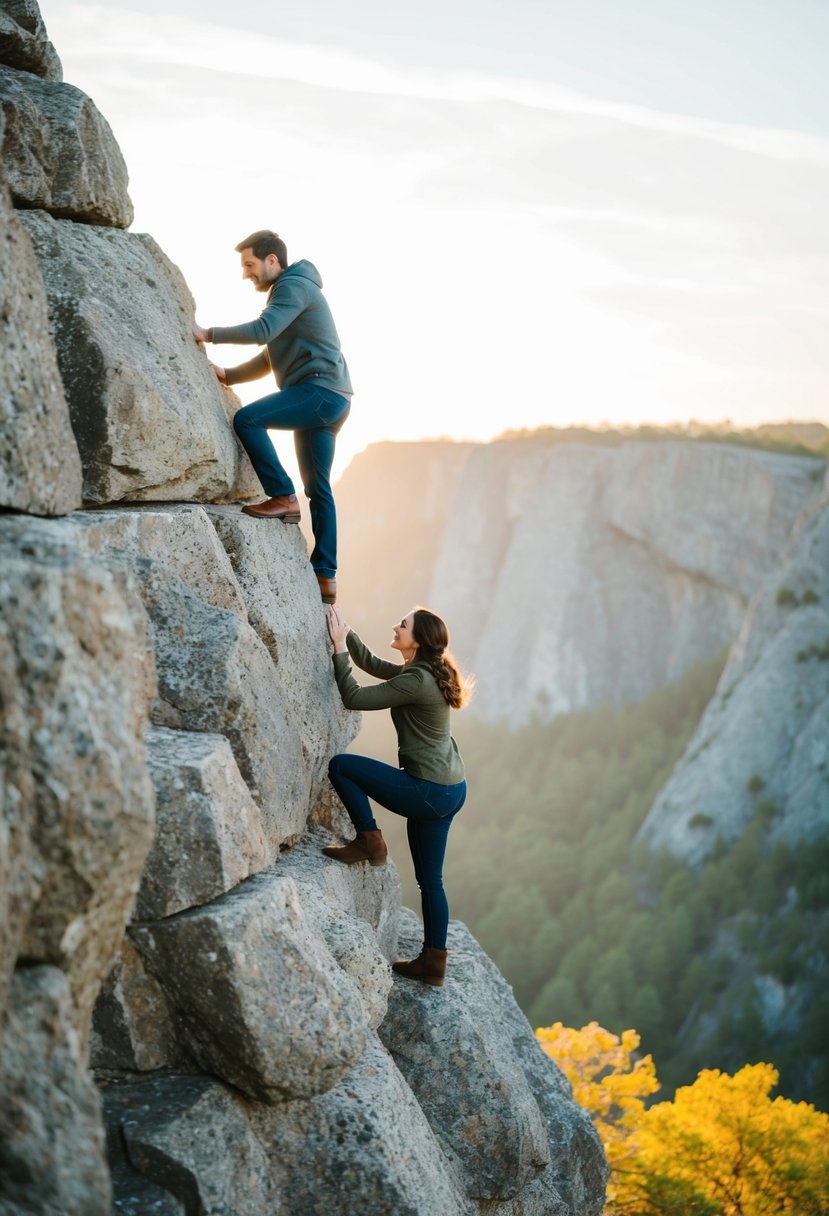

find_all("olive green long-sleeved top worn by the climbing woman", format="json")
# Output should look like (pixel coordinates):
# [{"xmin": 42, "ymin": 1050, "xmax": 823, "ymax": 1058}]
[{"xmin": 334, "ymin": 630, "xmax": 464, "ymax": 786}]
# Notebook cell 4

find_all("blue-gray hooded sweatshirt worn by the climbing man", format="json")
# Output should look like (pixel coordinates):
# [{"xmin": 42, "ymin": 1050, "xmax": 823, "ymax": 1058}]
[{"xmin": 210, "ymin": 260, "xmax": 354, "ymax": 396}]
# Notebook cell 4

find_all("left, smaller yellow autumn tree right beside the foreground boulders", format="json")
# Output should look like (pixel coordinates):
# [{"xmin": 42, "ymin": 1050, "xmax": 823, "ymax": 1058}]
[{"xmin": 535, "ymin": 1021, "xmax": 659, "ymax": 1211}]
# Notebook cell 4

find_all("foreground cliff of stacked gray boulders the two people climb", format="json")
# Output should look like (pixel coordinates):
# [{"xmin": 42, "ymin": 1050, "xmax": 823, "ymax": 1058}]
[{"xmin": 0, "ymin": 11, "xmax": 607, "ymax": 1216}]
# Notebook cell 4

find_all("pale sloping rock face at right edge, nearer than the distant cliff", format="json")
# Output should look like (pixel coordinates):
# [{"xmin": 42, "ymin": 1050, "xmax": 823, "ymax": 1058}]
[{"xmin": 641, "ymin": 471, "xmax": 829, "ymax": 863}]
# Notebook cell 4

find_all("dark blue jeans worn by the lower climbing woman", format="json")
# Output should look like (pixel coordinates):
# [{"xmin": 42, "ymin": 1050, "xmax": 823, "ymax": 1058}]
[{"xmin": 328, "ymin": 751, "xmax": 467, "ymax": 950}]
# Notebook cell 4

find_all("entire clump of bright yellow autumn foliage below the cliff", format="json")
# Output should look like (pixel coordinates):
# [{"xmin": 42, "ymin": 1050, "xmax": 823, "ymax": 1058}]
[{"xmin": 536, "ymin": 1021, "xmax": 829, "ymax": 1216}]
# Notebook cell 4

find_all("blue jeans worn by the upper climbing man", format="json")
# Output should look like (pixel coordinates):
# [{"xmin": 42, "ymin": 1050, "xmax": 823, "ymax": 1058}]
[{"xmin": 233, "ymin": 379, "xmax": 351, "ymax": 579}]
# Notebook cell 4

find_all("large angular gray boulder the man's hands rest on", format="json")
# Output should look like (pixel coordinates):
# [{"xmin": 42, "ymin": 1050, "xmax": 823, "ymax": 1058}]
[{"xmin": 21, "ymin": 212, "xmax": 261, "ymax": 503}]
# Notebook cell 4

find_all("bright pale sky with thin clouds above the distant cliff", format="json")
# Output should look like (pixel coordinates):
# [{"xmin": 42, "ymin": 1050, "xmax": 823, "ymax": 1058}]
[{"xmin": 41, "ymin": 0, "xmax": 829, "ymax": 473}]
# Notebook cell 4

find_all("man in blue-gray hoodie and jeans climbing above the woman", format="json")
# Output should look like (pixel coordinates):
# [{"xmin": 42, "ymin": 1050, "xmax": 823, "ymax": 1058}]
[{"xmin": 193, "ymin": 229, "xmax": 353, "ymax": 603}]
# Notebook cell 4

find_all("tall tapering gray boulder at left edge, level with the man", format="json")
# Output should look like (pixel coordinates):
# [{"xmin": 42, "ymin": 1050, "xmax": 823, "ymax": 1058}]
[{"xmin": 0, "ymin": 182, "xmax": 81, "ymax": 516}]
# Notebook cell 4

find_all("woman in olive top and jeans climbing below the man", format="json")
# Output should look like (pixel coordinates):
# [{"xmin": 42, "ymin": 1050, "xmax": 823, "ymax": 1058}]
[{"xmin": 322, "ymin": 607, "xmax": 469, "ymax": 987}]
